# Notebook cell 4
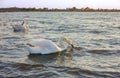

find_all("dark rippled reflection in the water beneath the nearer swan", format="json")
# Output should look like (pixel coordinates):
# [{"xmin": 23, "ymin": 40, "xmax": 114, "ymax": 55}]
[{"xmin": 28, "ymin": 48, "xmax": 73, "ymax": 65}]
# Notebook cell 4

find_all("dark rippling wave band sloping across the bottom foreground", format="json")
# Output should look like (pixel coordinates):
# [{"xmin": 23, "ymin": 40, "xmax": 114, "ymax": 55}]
[{"xmin": 0, "ymin": 62, "xmax": 120, "ymax": 78}]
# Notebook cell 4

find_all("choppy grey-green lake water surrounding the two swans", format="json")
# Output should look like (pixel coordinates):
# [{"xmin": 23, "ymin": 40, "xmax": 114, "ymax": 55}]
[{"xmin": 0, "ymin": 12, "xmax": 120, "ymax": 78}]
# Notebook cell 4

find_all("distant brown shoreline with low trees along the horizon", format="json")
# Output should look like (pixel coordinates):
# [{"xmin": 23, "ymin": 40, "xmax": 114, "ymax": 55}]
[{"xmin": 0, "ymin": 7, "xmax": 120, "ymax": 12}]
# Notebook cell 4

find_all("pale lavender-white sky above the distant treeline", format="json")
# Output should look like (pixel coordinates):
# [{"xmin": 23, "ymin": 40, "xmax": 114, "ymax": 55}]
[{"xmin": 0, "ymin": 0, "xmax": 120, "ymax": 9}]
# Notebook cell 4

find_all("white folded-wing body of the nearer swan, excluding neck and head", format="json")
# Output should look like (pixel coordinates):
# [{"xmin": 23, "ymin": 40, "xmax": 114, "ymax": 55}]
[{"xmin": 29, "ymin": 39, "xmax": 62, "ymax": 54}]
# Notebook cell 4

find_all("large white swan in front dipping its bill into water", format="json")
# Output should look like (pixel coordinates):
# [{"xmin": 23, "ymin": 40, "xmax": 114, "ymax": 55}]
[{"xmin": 27, "ymin": 38, "xmax": 73, "ymax": 54}]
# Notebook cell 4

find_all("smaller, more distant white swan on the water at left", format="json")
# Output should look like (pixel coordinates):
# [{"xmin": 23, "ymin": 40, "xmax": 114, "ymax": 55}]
[{"xmin": 13, "ymin": 21, "xmax": 29, "ymax": 32}]
